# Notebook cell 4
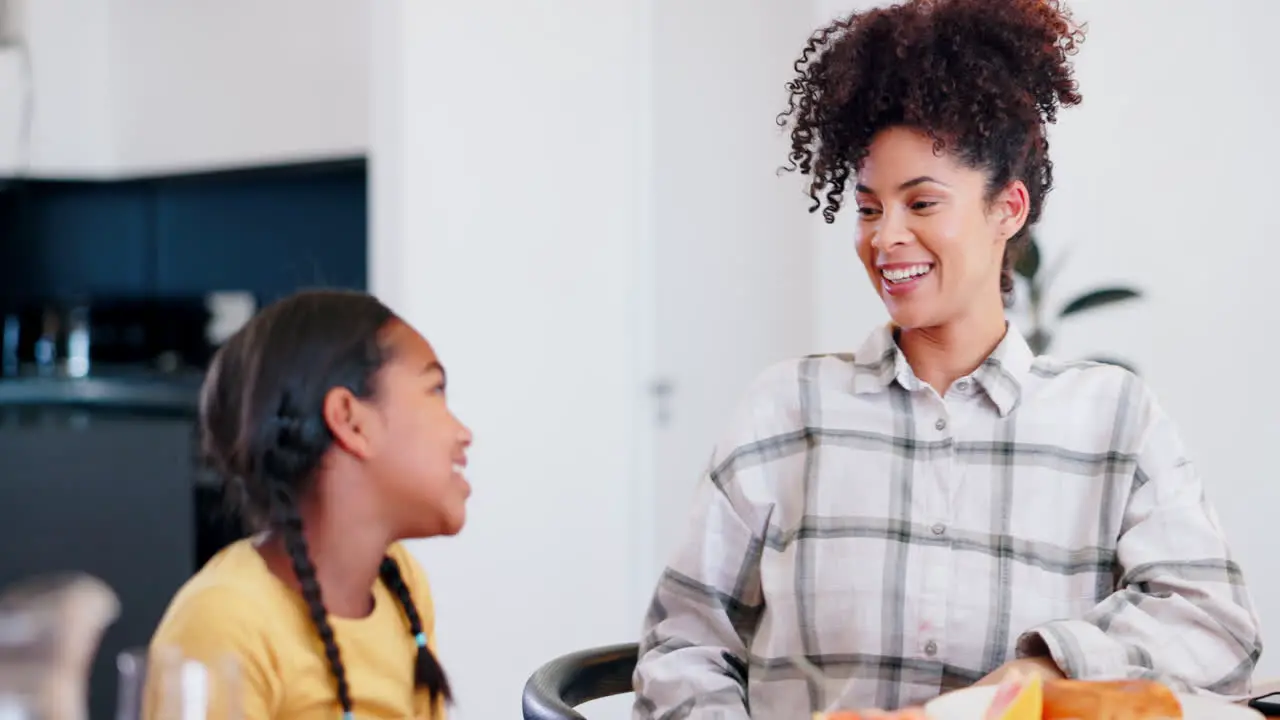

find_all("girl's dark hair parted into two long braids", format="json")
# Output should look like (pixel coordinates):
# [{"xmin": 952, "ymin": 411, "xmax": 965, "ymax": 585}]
[{"xmin": 200, "ymin": 291, "xmax": 452, "ymax": 719}]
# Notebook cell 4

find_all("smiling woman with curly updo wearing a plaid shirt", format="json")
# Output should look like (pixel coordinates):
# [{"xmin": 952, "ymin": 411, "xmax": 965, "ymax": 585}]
[{"xmin": 635, "ymin": 0, "xmax": 1261, "ymax": 719}]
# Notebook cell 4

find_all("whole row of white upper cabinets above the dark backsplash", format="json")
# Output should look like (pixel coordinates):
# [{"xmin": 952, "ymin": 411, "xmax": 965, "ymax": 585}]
[{"xmin": 0, "ymin": 0, "xmax": 371, "ymax": 178}]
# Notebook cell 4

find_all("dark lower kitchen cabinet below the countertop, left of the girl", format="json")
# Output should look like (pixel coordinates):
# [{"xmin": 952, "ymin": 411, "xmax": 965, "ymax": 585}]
[{"xmin": 0, "ymin": 406, "xmax": 196, "ymax": 720}]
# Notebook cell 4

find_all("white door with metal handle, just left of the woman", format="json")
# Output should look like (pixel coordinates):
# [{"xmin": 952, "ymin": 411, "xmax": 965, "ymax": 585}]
[{"xmin": 652, "ymin": 0, "xmax": 820, "ymax": 573}]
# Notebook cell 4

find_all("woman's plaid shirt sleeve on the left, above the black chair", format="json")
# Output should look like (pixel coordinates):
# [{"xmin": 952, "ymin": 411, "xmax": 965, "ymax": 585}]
[{"xmin": 632, "ymin": 361, "xmax": 799, "ymax": 720}]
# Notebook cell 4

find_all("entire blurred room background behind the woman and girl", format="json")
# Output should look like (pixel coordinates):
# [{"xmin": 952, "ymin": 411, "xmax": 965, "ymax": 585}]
[{"xmin": 0, "ymin": 0, "xmax": 1280, "ymax": 720}]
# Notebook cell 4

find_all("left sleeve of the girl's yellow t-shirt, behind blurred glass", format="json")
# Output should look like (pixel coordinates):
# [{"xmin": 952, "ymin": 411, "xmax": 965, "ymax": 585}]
[{"xmin": 142, "ymin": 587, "xmax": 283, "ymax": 720}]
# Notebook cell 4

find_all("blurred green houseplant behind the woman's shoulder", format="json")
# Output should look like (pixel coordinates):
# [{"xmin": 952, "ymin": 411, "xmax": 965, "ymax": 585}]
[{"xmin": 1014, "ymin": 234, "xmax": 1142, "ymax": 370}]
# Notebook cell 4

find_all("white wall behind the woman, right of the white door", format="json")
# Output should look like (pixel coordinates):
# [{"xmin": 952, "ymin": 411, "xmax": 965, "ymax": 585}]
[{"xmin": 814, "ymin": 0, "xmax": 1280, "ymax": 676}]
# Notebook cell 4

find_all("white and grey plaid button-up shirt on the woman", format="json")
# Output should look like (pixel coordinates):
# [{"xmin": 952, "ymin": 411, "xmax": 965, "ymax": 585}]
[{"xmin": 635, "ymin": 327, "xmax": 1261, "ymax": 720}]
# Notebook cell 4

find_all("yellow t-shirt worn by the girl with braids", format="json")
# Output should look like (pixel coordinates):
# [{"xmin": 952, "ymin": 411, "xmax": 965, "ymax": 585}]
[{"xmin": 147, "ymin": 539, "xmax": 444, "ymax": 720}]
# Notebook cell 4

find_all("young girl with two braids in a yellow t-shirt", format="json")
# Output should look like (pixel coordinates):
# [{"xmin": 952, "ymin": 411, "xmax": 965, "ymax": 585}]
[{"xmin": 147, "ymin": 291, "xmax": 471, "ymax": 720}]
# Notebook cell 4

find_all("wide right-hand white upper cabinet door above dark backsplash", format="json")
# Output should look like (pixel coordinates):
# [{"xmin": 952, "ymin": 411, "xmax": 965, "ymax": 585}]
[{"xmin": 109, "ymin": 0, "xmax": 372, "ymax": 174}]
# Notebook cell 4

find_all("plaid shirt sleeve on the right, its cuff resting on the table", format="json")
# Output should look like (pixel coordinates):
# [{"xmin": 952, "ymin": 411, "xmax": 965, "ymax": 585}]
[{"xmin": 1019, "ymin": 384, "xmax": 1262, "ymax": 697}]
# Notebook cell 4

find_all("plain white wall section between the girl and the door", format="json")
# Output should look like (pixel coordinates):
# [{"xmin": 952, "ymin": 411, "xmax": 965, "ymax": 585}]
[{"xmin": 372, "ymin": 0, "xmax": 648, "ymax": 720}]
